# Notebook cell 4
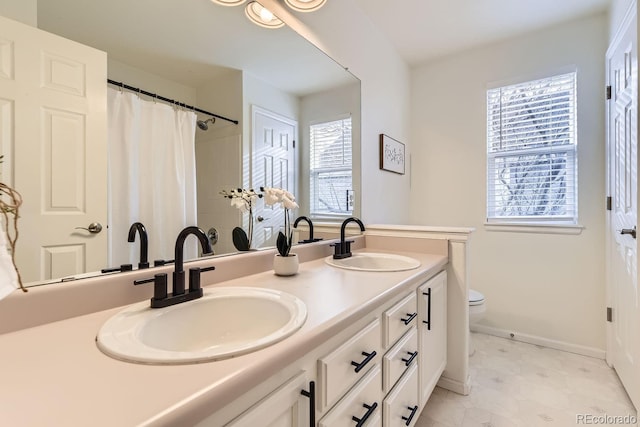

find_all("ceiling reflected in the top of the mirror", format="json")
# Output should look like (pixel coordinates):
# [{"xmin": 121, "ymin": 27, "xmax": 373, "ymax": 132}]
[{"xmin": 38, "ymin": 0, "xmax": 356, "ymax": 96}]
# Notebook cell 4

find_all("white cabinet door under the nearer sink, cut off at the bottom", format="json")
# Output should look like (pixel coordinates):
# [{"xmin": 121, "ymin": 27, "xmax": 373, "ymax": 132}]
[{"xmin": 227, "ymin": 372, "xmax": 310, "ymax": 427}]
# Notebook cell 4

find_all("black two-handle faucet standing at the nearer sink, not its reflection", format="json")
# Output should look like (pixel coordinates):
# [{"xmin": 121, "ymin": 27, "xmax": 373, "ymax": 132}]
[{"xmin": 133, "ymin": 226, "xmax": 215, "ymax": 308}]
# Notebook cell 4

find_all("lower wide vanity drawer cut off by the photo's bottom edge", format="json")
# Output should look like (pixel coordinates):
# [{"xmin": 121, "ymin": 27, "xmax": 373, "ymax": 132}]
[{"xmin": 318, "ymin": 364, "xmax": 382, "ymax": 427}]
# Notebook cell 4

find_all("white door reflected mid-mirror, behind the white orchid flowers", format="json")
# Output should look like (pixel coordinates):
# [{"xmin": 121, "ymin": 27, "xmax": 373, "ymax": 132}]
[{"xmin": 251, "ymin": 106, "xmax": 298, "ymax": 248}]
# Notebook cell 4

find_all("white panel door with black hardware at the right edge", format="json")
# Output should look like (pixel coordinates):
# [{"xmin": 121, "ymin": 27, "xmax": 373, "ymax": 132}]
[{"xmin": 607, "ymin": 5, "xmax": 640, "ymax": 407}]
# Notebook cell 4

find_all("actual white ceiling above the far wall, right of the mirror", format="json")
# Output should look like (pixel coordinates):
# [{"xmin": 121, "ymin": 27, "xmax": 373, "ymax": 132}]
[{"xmin": 356, "ymin": 0, "xmax": 611, "ymax": 65}]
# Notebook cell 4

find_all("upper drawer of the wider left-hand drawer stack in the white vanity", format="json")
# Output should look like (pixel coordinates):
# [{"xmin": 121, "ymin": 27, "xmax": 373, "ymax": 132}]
[{"xmin": 318, "ymin": 319, "xmax": 382, "ymax": 410}]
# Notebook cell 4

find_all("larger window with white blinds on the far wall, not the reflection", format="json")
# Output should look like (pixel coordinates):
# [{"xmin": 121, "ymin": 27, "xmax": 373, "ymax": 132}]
[{"xmin": 487, "ymin": 72, "xmax": 578, "ymax": 224}]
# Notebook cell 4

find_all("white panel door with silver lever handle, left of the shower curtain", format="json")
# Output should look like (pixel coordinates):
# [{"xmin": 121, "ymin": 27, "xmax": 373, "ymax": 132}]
[{"xmin": 0, "ymin": 17, "xmax": 107, "ymax": 282}]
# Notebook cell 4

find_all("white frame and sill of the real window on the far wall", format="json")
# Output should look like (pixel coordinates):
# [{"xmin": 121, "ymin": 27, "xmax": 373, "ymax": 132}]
[{"xmin": 485, "ymin": 69, "xmax": 582, "ymax": 229}]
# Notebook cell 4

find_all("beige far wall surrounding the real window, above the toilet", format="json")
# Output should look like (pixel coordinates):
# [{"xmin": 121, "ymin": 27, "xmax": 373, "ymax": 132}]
[{"xmin": 410, "ymin": 15, "xmax": 607, "ymax": 349}]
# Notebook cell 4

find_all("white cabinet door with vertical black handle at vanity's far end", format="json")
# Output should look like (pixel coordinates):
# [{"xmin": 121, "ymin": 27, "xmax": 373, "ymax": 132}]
[{"xmin": 418, "ymin": 271, "xmax": 447, "ymax": 408}]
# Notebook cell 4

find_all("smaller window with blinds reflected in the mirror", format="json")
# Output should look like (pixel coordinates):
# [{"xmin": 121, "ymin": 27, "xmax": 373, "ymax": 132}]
[{"xmin": 309, "ymin": 117, "xmax": 353, "ymax": 217}]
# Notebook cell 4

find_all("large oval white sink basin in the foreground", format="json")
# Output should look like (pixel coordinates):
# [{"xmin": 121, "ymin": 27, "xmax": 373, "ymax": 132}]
[{"xmin": 96, "ymin": 287, "xmax": 307, "ymax": 364}]
